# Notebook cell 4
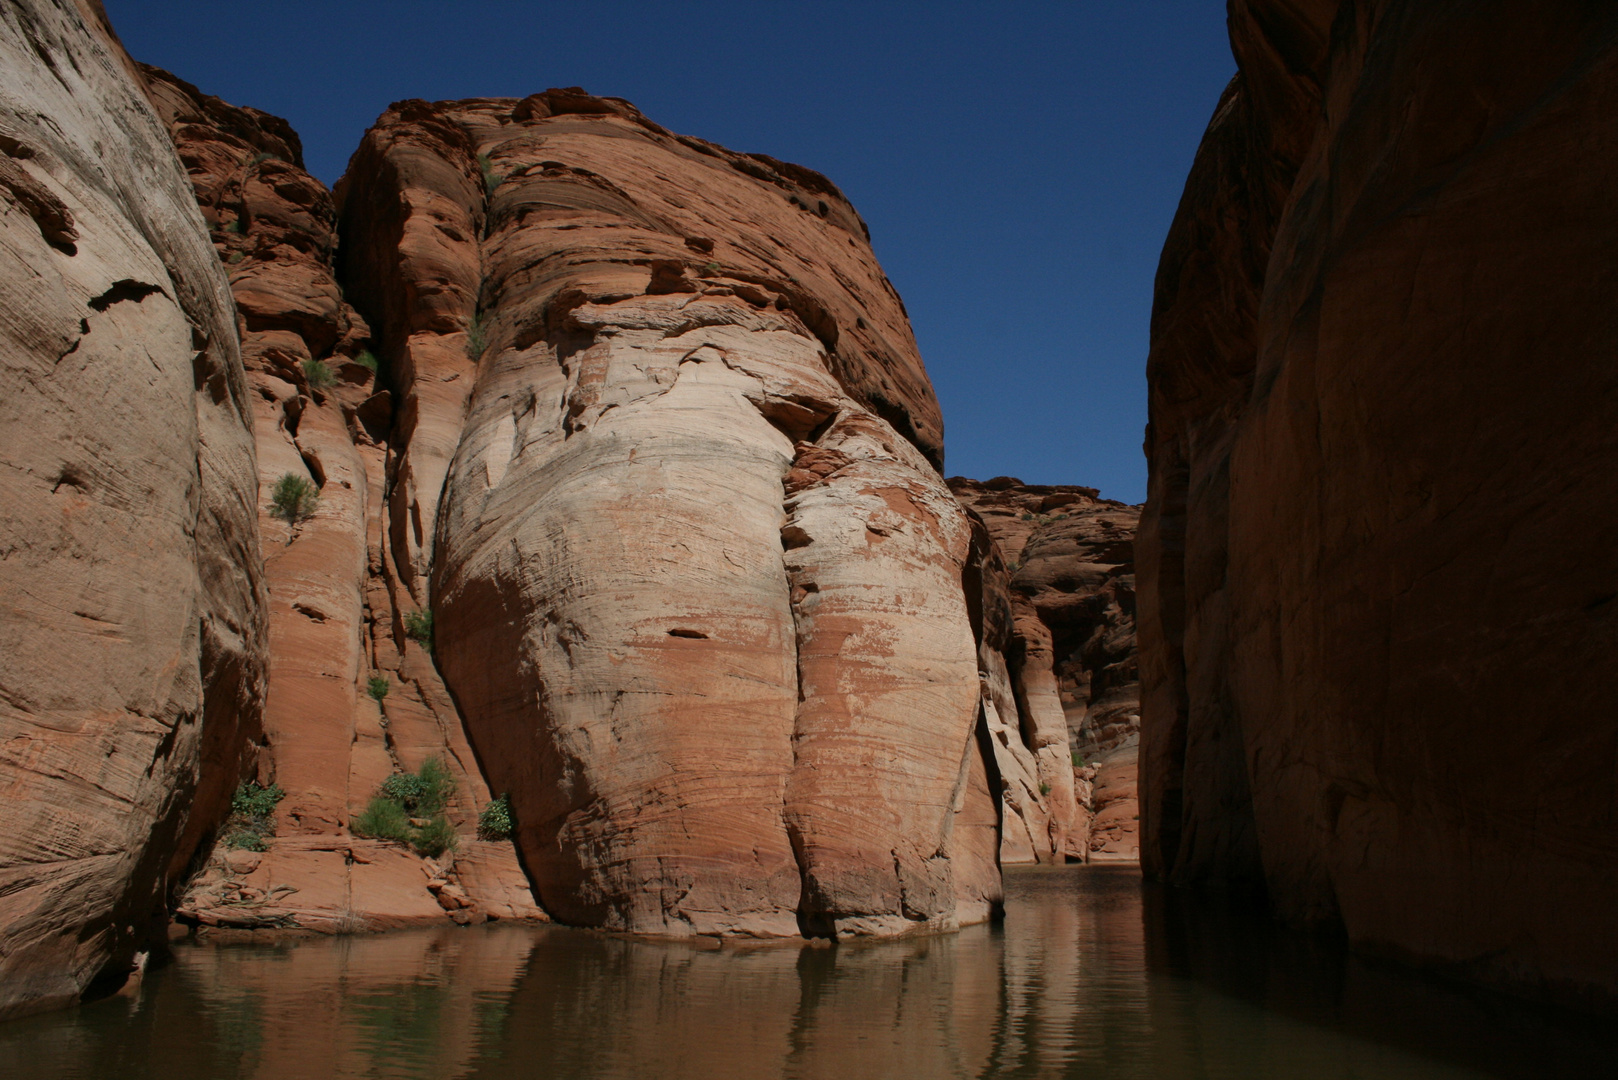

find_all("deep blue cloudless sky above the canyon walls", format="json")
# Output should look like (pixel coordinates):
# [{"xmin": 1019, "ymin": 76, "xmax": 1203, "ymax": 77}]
[{"xmin": 105, "ymin": 0, "xmax": 1235, "ymax": 502}]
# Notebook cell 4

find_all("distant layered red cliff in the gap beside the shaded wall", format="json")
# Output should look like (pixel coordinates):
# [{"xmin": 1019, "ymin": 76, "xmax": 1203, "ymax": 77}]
[{"xmin": 950, "ymin": 476, "xmax": 1139, "ymax": 863}]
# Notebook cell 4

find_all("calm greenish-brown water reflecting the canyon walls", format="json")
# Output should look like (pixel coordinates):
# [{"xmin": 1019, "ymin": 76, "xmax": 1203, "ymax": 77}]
[{"xmin": 0, "ymin": 866, "xmax": 1618, "ymax": 1080}]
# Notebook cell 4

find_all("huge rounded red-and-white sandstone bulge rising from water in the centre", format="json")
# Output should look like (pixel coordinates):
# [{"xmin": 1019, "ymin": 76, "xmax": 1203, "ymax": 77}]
[{"xmin": 338, "ymin": 91, "xmax": 998, "ymax": 936}]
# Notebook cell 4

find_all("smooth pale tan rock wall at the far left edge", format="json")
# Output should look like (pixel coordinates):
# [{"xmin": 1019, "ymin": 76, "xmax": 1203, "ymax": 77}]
[{"xmin": 0, "ymin": 0, "xmax": 265, "ymax": 1015}]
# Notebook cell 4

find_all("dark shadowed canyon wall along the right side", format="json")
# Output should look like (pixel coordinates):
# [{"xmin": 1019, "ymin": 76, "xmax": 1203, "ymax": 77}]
[{"xmin": 1139, "ymin": 0, "xmax": 1618, "ymax": 1007}]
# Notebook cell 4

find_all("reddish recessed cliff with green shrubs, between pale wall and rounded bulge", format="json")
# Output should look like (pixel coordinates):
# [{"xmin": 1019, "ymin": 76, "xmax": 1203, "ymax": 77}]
[{"xmin": 141, "ymin": 66, "xmax": 540, "ymax": 931}]
